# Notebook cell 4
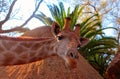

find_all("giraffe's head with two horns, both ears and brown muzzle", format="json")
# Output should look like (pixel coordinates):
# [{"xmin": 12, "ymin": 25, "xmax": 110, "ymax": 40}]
[{"xmin": 51, "ymin": 18, "xmax": 88, "ymax": 69}]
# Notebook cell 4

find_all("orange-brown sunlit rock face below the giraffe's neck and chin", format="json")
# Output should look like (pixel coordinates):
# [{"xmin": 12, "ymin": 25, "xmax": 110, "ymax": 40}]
[{"xmin": 0, "ymin": 55, "xmax": 103, "ymax": 79}]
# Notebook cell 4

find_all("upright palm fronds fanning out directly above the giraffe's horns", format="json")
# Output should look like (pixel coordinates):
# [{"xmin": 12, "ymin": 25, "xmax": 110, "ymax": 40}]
[{"xmin": 48, "ymin": 2, "xmax": 84, "ymax": 29}]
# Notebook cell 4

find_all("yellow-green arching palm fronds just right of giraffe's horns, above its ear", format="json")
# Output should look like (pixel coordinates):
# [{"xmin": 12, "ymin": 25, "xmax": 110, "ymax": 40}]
[{"xmin": 80, "ymin": 14, "xmax": 103, "ymax": 38}]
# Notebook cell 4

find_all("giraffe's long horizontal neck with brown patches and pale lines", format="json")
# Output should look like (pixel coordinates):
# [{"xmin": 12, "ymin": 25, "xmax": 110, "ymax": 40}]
[{"xmin": 0, "ymin": 37, "xmax": 56, "ymax": 66}]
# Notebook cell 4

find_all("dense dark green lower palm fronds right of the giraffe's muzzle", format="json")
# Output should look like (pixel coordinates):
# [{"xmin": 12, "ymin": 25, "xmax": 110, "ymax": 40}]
[{"xmin": 80, "ymin": 37, "xmax": 118, "ymax": 75}]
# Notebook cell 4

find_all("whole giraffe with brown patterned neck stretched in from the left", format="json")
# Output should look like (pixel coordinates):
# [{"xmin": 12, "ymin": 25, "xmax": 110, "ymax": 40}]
[{"xmin": 0, "ymin": 18, "xmax": 89, "ymax": 68}]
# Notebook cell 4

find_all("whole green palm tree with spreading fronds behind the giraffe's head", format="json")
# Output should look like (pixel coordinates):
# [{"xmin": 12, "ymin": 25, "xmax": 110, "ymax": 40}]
[{"xmin": 35, "ymin": 2, "xmax": 118, "ymax": 76}]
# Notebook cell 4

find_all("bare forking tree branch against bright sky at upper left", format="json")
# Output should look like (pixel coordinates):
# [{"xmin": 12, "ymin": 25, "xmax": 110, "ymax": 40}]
[{"xmin": 0, "ymin": 0, "xmax": 43, "ymax": 33}]
